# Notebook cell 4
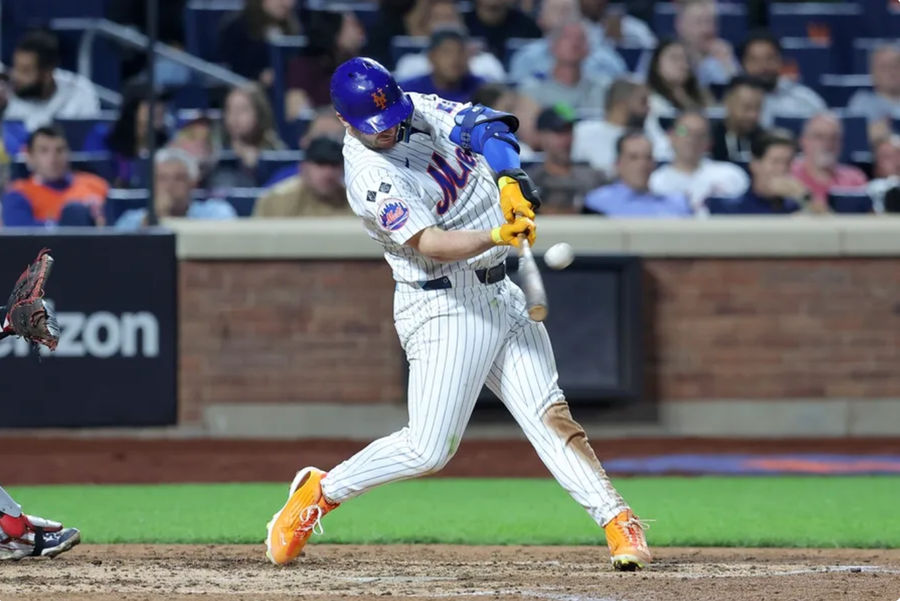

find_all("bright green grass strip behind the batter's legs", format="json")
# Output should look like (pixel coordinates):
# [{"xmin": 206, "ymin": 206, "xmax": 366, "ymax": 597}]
[{"xmin": 3, "ymin": 476, "xmax": 900, "ymax": 547}]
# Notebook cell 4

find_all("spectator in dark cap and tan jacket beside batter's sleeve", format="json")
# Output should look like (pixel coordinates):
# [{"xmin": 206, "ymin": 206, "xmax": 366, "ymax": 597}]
[{"xmin": 253, "ymin": 138, "xmax": 353, "ymax": 217}]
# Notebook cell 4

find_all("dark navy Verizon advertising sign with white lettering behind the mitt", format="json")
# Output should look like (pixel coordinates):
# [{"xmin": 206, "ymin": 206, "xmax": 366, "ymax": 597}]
[{"xmin": 0, "ymin": 230, "xmax": 177, "ymax": 428}]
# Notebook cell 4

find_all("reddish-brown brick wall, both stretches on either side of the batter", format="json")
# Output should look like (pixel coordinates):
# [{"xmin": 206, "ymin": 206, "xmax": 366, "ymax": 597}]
[{"xmin": 179, "ymin": 259, "xmax": 900, "ymax": 423}]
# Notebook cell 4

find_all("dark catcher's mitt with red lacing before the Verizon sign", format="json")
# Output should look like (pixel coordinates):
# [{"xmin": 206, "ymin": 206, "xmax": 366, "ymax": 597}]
[{"xmin": 0, "ymin": 248, "xmax": 59, "ymax": 351}]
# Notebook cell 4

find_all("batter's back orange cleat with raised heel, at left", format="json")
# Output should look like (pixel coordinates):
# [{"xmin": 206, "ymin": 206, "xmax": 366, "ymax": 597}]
[{"xmin": 266, "ymin": 467, "xmax": 339, "ymax": 566}]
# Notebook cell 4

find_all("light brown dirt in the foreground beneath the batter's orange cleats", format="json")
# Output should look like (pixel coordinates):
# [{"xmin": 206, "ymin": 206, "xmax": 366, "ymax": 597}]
[{"xmin": 0, "ymin": 545, "xmax": 900, "ymax": 601}]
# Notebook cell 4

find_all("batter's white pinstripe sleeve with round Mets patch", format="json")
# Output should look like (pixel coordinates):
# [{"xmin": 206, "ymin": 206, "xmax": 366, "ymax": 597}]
[{"xmin": 347, "ymin": 168, "xmax": 437, "ymax": 245}]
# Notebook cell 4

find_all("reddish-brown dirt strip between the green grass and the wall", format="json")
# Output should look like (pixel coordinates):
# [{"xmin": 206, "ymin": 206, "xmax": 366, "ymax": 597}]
[{"xmin": 0, "ymin": 436, "xmax": 900, "ymax": 486}]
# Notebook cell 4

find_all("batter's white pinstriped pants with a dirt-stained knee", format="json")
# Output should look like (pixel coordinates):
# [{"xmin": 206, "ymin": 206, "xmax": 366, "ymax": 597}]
[{"xmin": 322, "ymin": 272, "xmax": 627, "ymax": 526}]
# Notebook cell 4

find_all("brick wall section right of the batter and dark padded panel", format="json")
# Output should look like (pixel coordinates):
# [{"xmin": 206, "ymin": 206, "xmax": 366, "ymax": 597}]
[{"xmin": 645, "ymin": 259, "xmax": 900, "ymax": 400}]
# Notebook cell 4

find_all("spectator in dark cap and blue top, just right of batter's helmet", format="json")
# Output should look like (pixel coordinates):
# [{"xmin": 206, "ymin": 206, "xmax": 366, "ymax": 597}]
[{"xmin": 400, "ymin": 28, "xmax": 484, "ymax": 102}]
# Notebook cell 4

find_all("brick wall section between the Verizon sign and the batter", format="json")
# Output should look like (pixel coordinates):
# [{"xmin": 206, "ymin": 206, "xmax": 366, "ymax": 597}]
[{"xmin": 178, "ymin": 261, "xmax": 405, "ymax": 423}]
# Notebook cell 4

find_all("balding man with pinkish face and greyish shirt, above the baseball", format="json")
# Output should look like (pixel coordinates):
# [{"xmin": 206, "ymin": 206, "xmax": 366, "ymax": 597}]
[{"xmin": 519, "ymin": 21, "xmax": 610, "ymax": 112}]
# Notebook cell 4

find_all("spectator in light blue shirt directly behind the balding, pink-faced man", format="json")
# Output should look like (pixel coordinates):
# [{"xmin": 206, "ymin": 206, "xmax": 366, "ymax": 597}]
[{"xmin": 509, "ymin": 0, "xmax": 628, "ymax": 81}]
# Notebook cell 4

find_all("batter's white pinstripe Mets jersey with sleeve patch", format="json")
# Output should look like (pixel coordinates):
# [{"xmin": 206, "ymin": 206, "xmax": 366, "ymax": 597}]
[{"xmin": 344, "ymin": 93, "xmax": 509, "ymax": 282}]
